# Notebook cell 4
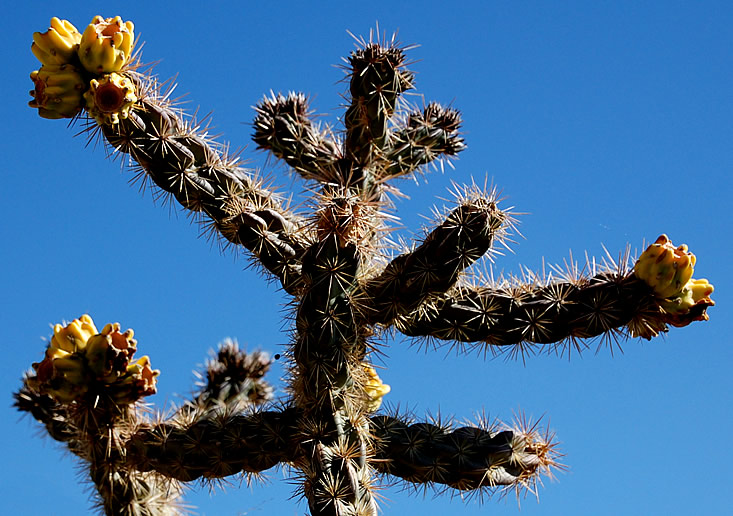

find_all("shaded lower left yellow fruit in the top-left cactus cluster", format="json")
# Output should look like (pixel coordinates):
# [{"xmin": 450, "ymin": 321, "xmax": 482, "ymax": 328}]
[{"xmin": 28, "ymin": 64, "xmax": 84, "ymax": 119}]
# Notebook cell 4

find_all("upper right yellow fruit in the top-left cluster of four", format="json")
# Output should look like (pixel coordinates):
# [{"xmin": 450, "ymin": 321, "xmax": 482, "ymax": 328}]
[{"xmin": 78, "ymin": 16, "xmax": 135, "ymax": 74}]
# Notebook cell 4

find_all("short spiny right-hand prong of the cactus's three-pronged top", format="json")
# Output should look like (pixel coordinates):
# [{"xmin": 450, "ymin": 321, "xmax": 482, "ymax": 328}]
[{"xmin": 382, "ymin": 103, "xmax": 466, "ymax": 179}]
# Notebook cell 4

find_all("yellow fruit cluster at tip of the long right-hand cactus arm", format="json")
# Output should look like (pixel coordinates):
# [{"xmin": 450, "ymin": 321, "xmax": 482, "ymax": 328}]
[{"xmin": 634, "ymin": 235, "xmax": 715, "ymax": 327}]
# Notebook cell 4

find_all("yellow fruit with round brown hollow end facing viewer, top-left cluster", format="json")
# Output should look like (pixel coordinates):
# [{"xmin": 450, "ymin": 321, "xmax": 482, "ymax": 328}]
[{"xmin": 84, "ymin": 73, "xmax": 137, "ymax": 125}]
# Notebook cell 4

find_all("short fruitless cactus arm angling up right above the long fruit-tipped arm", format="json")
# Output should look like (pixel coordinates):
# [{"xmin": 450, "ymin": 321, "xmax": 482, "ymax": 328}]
[{"xmin": 363, "ymin": 197, "xmax": 511, "ymax": 324}]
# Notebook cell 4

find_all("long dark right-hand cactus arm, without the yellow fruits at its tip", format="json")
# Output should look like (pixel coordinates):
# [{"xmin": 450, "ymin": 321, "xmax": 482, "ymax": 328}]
[{"xmin": 396, "ymin": 272, "xmax": 666, "ymax": 346}]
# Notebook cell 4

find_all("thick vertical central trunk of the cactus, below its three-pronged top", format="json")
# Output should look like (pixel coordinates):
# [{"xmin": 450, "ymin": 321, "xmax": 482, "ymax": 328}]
[{"xmin": 292, "ymin": 235, "xmax": 376, "ymax": 516}]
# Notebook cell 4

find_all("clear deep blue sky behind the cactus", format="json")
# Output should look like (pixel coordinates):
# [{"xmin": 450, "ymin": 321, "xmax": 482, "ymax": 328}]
[{"xmin": 0, "ymin": 1, "xmax": 733, "ymax": 516}]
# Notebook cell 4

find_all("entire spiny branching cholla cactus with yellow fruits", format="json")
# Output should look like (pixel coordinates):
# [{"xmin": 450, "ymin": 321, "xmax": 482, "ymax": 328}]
[{"xmin": 16, "ymin": 17, "xmax": 713, "ymax": 515}]
